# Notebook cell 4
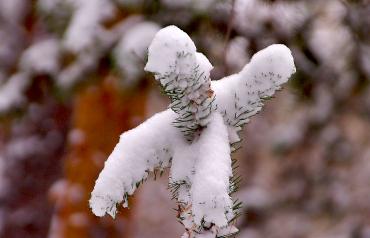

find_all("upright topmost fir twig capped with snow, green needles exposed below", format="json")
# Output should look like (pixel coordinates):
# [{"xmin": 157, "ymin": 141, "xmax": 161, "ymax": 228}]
[{"xmin": 145, "ymin": 26, "xmax": 214, "ymax": 140}]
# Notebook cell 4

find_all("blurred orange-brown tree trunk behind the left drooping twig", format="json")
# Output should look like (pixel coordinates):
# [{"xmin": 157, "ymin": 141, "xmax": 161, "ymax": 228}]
[{"xmin": 49, "ymin": 76, "xmax": 147, "ymax": 238}]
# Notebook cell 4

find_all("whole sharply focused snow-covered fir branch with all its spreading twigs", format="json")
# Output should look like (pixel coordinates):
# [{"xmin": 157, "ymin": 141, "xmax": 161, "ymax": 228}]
[{"xmin": 90, "ymin": 26, "xmax": 295, "ymax": 238}]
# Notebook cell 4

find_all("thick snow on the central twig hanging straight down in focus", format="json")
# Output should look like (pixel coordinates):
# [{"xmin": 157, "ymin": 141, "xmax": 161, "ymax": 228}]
[{"xmin": 191, "ymin": 112, "xmax": 232, "ymax": 227}]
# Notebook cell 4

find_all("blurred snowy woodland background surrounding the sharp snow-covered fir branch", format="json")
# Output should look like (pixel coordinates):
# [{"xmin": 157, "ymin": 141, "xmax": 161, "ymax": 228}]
[{"xmin": 0, "ymin": 0, "xmax": 370, "ymax": 238}]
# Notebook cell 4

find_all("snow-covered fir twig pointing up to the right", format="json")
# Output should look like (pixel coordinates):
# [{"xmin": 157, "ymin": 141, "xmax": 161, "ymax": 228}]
[{"xmin": 212, "ymin": 42, "xmax": 295, "ymax": 128}]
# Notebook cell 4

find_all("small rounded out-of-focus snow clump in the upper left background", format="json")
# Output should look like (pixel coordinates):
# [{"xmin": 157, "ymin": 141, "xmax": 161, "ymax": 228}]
[{"xmin": 20, "ymin": 39, "xmax": 60, "ymax": 75}]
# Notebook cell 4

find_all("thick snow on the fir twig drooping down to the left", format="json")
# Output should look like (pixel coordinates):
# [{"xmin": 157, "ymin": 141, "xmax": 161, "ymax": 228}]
[{"xmin": 90, "ymin": 110, "xmax": 184, "ymax": 217}]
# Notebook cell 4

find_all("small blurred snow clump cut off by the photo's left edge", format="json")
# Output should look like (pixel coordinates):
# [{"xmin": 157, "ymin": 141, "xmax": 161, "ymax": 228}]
[{"xmin": 0, "ymin": 73, "xmax": 29, "ymax": 113}]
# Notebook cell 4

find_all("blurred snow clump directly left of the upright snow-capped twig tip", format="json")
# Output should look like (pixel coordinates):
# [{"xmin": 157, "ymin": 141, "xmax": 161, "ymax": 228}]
[{"xmin": 113, "ymin": 22, "xmax": 160, "ymax": 85}]
